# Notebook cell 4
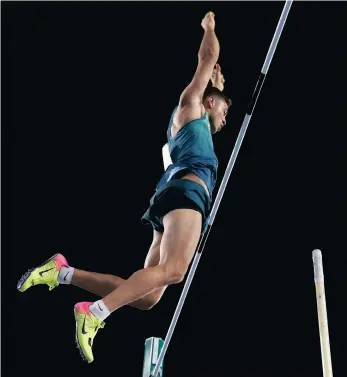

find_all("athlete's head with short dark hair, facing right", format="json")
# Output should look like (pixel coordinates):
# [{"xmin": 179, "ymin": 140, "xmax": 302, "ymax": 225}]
[{"xmin": 203, "ymin": 86, "xmax": 231, "ymax": 134}]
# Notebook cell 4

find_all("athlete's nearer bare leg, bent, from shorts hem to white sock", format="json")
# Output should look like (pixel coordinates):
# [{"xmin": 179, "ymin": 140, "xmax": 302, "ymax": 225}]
[{"xmin": 102, "ymin": 209, "xmax": 202, "ymax": 312}]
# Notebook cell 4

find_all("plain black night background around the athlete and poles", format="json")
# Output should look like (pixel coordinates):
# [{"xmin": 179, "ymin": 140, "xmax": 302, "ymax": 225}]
[{"xmin": 2, "ymin": 2, "xmax": 347, "ymax": 377}]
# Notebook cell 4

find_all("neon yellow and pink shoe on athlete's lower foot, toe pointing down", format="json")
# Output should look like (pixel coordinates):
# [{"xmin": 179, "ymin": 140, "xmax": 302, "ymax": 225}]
[{"xmin": 74, "ymin": 302, "xmax": 105, "ymax": 363}]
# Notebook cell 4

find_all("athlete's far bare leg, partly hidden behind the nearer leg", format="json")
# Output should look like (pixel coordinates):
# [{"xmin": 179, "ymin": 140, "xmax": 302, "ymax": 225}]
[{"xmin": 71, "ymin": 230, "xmax": 166, "ymax": 310}]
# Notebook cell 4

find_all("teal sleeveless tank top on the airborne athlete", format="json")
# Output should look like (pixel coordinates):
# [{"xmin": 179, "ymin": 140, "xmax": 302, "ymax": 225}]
[{"xmin": 156, "ymin": 107, "xmax": 218, "ymax": 199}]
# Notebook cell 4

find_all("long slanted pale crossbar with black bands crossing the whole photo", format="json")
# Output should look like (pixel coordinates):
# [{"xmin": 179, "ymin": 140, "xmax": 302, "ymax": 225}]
[{"xmin": 150, "ymin": 0, "xmax": 292, "ymax": 377}]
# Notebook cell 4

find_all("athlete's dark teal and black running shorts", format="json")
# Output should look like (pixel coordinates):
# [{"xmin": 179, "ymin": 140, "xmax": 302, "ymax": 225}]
[{"xmin": 141, "ymin": 179, "xmax": 211, "ymax": 233}]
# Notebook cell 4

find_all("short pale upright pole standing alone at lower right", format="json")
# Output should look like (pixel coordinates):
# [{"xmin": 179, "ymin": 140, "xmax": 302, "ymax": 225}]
[{"xmin": 312, "ymin": 249, "xmax": 333, "ymax": 377}]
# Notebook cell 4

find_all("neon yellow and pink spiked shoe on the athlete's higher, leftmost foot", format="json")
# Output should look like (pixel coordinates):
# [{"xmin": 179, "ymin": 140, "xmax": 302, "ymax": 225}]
[{"xmin": 17, "ymin": 254, "xmax": 69, "ymax": 292}]
